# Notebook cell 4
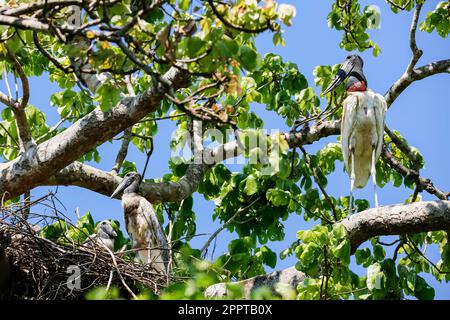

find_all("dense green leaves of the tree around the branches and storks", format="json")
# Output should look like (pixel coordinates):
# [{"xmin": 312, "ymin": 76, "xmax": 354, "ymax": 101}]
[{"xmin": 0, "ymin": 0, "xmax": 450, "ymax": 299}]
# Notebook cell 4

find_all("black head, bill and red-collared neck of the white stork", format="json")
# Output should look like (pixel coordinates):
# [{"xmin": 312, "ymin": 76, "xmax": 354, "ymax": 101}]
[{"xmin": 323, "ymin": 54, "xmax": 367, "ymax": 94}]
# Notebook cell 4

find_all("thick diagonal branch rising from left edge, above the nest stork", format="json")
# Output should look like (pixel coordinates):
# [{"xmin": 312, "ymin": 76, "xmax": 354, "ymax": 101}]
[{"xmin": 0, "ymin": 67, "xmax": 188, "ymax": 198}]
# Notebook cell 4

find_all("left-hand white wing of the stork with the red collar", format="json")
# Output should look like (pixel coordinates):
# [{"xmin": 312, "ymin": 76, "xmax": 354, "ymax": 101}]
[{"xmin": 341, "ymin": 94, "xmax": 358, "ymax": 172}]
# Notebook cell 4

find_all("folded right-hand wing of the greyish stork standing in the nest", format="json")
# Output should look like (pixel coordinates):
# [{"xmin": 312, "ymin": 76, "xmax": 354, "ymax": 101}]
[{"xmin": 140, "ymin": 197, "xmax": 169, "ymax": 264}]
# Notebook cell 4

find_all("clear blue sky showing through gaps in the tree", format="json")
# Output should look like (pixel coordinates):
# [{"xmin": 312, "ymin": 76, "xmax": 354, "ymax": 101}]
[{"xmin": 0, "ymin": 0, "xmax": 450, "ymax": 299}]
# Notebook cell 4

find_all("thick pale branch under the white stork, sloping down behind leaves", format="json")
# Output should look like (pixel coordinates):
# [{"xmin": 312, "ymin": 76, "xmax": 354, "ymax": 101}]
[{"xmin": 205, "ymin": 201, "xmax": 450, "ymax": 299}]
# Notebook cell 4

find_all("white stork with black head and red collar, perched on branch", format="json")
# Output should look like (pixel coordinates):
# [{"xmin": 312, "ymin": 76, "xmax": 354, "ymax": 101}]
[{"xmin": 324, "ymin": 55, "xmax": 387, "ymax": 213}]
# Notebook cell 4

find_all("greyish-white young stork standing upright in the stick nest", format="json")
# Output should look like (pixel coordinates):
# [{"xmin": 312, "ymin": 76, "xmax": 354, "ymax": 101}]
[{"xmin": 111, "ymin": 172, "xmax": 169, "ymax": 273}]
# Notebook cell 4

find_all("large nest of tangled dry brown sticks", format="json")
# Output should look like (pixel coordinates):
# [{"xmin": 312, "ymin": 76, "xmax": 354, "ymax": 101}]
[{"xmin": 0, "ymin": 194, "xmax": 173, "ymax": 300}]
